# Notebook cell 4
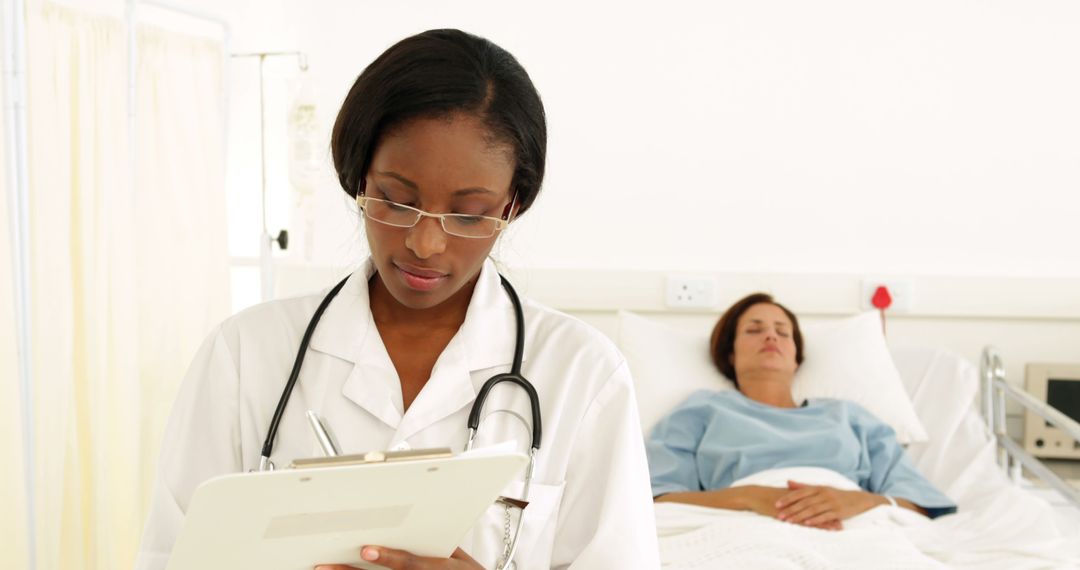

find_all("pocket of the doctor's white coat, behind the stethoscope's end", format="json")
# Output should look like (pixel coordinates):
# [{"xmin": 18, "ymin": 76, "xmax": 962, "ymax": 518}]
[{"xmin": 474, "ymin": 481, "xmax": 566, "ymax": 570}]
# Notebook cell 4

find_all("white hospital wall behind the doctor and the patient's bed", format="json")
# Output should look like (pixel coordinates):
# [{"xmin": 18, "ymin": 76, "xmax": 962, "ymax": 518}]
[{"xmin": 76, "ymin": 0, "xmax": 1080, "ymax": 412}]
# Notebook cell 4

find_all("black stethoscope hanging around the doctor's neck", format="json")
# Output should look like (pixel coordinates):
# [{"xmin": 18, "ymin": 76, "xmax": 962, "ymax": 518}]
[{"xmin": 253, "ymin": 269, "xmax": 540, "ymax": 570}]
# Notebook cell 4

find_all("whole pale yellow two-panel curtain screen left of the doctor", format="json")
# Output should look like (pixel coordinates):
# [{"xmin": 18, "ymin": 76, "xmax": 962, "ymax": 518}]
[{"xmin": 27, "ymin": 2, "xmax": 228, "ymax": 570}]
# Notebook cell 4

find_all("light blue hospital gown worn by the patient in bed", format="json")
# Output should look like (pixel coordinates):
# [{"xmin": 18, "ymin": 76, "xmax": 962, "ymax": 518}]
[{"xmin": 646, "ymin": 390, "xmax": 956, "ymax": 518}]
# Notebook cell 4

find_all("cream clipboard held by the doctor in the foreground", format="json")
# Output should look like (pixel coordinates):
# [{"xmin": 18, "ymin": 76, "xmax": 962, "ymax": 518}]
[{"xmin": 166, "ymin": 450, "xmax": 528, "ymax": 570}]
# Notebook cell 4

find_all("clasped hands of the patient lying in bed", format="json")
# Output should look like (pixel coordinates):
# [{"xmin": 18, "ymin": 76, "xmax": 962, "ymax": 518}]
[{"xmin": 775, "ymin": 480, "xmax": 886, "ymax": 530}]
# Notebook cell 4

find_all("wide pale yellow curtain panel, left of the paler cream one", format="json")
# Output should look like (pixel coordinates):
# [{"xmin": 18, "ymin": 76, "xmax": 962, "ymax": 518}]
[{"xmin": 27, "ymin": 3, "xmax": 139, "ymax": 570}]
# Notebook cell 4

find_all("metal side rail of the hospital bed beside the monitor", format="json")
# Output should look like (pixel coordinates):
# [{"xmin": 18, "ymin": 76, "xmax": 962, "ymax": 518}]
[{"xmin": 980, "ymin": 347, "xmax": 1080, "ymax": 506}]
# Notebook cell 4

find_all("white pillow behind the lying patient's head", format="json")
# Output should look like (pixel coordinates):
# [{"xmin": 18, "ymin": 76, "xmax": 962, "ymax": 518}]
[{"xmin": 616, "ymin": 311, "xmax": 927, "ymax": 444}]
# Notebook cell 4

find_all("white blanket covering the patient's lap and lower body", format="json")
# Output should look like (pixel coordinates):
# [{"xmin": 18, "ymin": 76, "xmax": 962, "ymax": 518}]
[{"xmin": 656, "ymin": 467, "xmax": 1080, "ymax": 570}]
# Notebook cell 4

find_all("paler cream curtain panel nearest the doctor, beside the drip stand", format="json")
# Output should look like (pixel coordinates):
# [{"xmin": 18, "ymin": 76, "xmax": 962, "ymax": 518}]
[{"xmin": 135, "ymin": 21, "xmax": 230, "ymax": 520}]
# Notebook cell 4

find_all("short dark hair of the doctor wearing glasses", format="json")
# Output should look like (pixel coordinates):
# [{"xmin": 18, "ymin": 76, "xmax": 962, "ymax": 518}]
[{"xmin": 330, "ymin": 29, "xmax": 548, "ymax": 213}]
